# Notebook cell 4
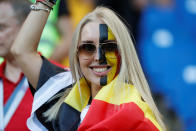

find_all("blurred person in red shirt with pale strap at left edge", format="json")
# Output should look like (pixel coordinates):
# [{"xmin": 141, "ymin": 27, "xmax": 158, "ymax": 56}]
[{"xmin": 0, "ymin": 0, "xmax": 33, "ymax": 131}]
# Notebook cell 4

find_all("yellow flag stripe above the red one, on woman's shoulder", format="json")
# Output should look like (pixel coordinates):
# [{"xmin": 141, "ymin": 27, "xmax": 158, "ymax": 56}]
[{"xmin": 94, "ymin": 78, "xmax": 162, "ymax": 131}]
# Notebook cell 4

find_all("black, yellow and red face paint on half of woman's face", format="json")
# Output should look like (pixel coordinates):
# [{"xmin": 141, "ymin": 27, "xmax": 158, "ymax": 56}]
[{"xmin": 99, "ymin": 24, "xmax": 120, "ymax": 86}]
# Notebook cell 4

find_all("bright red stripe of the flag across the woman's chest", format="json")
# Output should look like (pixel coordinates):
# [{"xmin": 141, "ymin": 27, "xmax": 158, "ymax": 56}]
[{"xmin": 78, "ymin": 99, "xmax": 158, "ymax": 131}]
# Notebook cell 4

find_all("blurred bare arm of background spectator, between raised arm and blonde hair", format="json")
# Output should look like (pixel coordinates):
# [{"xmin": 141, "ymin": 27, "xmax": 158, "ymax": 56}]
[{"xmin": 50, "ymin": 0, "xmax": 74, "ymax": 66}]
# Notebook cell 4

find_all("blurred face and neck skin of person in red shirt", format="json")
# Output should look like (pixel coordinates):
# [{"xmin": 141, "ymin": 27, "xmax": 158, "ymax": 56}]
[{"xmin": 0, "ymin": 2, "xmax": 21, "ymax": 82}]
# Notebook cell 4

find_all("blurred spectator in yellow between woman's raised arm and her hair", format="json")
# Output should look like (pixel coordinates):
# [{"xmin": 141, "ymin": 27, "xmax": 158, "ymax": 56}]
[{"xmin": 51, "ymin": 0, "xmax": 93, "ymax": 66}]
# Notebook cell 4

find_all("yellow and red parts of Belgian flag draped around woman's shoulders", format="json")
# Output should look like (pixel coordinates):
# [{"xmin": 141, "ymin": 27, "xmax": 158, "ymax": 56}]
[{"xmin": 61, "ymin": 78, "xmax": 162, "ymax": 131}]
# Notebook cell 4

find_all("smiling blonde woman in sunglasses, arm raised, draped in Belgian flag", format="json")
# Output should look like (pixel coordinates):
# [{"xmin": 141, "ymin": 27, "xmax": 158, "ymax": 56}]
[{"xmin": 12, "ymin": 0, "xmax": 165, "ymax": 131}]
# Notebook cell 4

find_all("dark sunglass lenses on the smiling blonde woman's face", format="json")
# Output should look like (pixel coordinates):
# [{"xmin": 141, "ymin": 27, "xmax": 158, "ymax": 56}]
[{"xmin": 78, "ymin": 42, "xmax": 118, "ymax": 54}]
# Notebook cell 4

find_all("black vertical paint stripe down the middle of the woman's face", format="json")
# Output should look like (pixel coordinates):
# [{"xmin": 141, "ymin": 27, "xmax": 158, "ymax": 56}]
[{"xmin": 99, "ymin": 24, "xmax": 108, "ymax": 86}]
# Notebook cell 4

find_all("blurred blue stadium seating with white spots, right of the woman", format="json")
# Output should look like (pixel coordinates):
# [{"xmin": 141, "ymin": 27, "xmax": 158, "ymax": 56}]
[{"xmin": 138, "ymin": 0, "xmax": 196, "ymax": 131}]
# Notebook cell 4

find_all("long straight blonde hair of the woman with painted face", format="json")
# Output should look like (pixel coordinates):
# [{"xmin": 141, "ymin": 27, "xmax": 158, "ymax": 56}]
[{"xmin": 44, "ymin": 7, "xmax": 165, "ymax": 130}]
